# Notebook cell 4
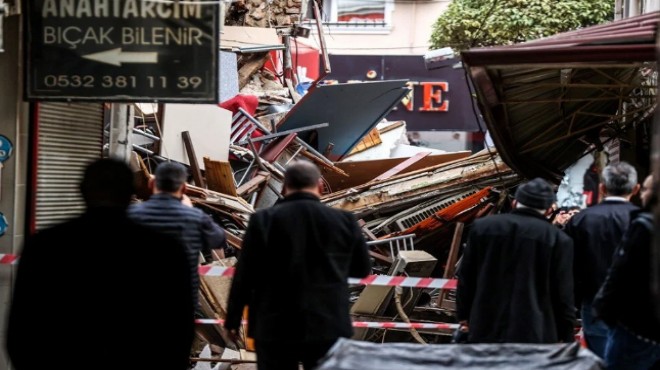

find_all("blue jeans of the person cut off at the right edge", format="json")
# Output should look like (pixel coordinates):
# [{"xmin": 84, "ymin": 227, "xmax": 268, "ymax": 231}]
[{"xmin": 605, "ymin": 325, "xmax": 660, "ymax": 370}]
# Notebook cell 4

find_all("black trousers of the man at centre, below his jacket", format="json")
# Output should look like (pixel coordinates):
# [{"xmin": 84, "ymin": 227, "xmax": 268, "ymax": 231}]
[{"xmin": 254, "ymin": 340, "xmax": 336, "ymax": 370}]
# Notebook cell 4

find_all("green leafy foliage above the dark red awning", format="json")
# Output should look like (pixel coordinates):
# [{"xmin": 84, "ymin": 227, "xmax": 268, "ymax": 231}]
[{"xmin": 431, "ymin": 0, "xmax": 614, "ymax": 50}]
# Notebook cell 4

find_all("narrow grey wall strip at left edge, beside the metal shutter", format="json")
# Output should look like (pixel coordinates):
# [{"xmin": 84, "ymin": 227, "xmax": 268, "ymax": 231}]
[{"xmin": 0, "ymin": 16, "xmax": 29, "ymax": 369}]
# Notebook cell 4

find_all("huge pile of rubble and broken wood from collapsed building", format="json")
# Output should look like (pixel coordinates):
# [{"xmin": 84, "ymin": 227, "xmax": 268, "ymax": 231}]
[{"xmin": 124, "ymin": 0, "xmax": 521, "ymax": 369}]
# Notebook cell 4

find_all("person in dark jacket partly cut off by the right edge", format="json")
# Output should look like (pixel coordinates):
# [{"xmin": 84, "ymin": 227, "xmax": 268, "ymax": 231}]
[{"xmin": 593, "ymin": 176, "xmax": 660, "ymax": 370}]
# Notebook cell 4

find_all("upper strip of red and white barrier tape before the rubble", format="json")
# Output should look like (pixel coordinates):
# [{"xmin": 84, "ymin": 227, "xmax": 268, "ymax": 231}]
[{"xmin": 0, "ymin": 254, "xmax": 457, "ymax": 290}]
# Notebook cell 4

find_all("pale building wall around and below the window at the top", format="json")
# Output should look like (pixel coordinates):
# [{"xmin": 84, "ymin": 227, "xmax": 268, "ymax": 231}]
[{"xmin": 312, "ymin": 0, "xmax": 451, "ymax": 55}]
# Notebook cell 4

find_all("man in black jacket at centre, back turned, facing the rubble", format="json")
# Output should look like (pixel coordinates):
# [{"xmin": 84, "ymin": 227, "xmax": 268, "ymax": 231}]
[{"xmin": 225, "ymin": 162, "xmax": 371, "ymax": 370}]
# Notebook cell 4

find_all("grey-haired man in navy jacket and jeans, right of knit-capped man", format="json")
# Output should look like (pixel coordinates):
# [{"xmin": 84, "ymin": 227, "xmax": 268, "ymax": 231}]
[{"xmin": 564, "ymin": 162, "xmax": 639, "ymax": 358}]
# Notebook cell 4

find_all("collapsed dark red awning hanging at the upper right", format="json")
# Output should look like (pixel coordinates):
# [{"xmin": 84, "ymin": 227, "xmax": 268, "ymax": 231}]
[{"xmin": 462, "ymin": 12, "xmax": 660, "ymax": 181}]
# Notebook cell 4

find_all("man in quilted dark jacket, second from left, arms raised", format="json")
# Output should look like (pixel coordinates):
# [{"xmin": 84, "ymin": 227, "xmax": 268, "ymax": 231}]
[{"xmin": 129, "ymin": 162, "xmax": 226, "ymax": 304}]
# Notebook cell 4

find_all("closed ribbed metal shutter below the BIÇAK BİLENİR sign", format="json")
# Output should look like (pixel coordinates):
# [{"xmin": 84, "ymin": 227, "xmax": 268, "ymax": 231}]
[{"xmin": 34, "ymin": 103, "xmax": 103, "ymax": 230}]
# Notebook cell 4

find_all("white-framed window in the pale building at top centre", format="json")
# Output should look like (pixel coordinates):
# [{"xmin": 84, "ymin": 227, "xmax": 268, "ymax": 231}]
[{"xmin": 323, "ymin": 0, "xmax": 394, "ymax": 29}]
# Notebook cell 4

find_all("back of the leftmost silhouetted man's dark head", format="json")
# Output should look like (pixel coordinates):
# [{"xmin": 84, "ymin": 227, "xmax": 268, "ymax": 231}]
[{"xmin": 80, "ymin": 158, "xmax": 135, "ymax": 208}]
